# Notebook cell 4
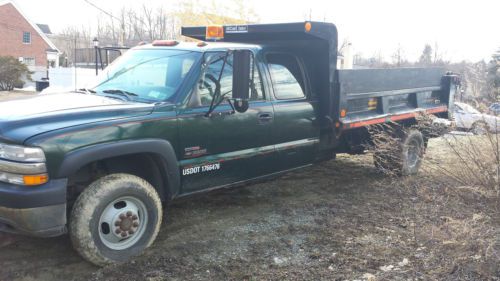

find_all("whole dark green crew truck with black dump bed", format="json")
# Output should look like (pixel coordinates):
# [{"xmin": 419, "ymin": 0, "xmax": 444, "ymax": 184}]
[{"xmin": 0, "ymin": 22, "xmax": 459, "ymax": 265}]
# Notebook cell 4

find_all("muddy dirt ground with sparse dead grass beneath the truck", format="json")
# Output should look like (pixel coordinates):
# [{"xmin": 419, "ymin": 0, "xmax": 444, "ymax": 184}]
[{"xmin": 0, "ymin": 135, "xmax": 500, "ymax": 281}]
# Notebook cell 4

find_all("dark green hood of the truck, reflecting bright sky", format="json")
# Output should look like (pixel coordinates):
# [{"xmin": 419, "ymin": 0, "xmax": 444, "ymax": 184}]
[{"xmin": 0, "ymin": 93, "xmax": 154, "ymax": 143}]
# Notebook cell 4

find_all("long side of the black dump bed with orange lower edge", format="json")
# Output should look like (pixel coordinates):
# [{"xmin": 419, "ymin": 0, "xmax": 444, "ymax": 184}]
[{"xmin": 338, "ymin": 68, "xmax": 457, "ymax": 129}]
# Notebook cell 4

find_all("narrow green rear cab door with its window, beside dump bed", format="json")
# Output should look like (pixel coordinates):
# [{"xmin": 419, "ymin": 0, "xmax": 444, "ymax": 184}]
[{"xmin": 266, "ymin": 53, "xmax": 319, "ymax": 170}]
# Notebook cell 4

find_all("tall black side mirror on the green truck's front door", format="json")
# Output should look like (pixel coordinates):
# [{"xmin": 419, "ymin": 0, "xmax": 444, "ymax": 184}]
[{"xmin": 233, "ymin": 50, "xmax": 253, "ymax": 113}]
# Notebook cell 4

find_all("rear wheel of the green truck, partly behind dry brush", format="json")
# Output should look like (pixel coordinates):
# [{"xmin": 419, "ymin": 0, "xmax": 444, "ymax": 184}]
[{"xmin": 373, "ymin": 129, "xmax": 425, "ymax": 175}]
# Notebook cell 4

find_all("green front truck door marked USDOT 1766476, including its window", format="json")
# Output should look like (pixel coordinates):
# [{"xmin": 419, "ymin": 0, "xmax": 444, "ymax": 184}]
[{"xmin": 178, "ymin": 52, "xmax": 275, "ymax": 193}]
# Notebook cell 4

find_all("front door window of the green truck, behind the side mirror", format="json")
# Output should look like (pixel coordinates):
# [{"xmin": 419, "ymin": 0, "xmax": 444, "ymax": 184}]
[{"xmin": 190, "ymin": 52, "xmax": 264, "ymax": 107}]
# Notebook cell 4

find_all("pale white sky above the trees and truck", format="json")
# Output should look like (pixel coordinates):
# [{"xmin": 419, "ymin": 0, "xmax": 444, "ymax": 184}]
[{"xmin": 11, "ymin": 0, "xmax": 500, "ymax": 61}]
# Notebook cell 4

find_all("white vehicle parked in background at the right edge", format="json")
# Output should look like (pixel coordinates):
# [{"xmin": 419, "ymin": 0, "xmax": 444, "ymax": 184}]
[{"xmin": 454, "ymin": 102, "xmax": 500, "ymax": 135}]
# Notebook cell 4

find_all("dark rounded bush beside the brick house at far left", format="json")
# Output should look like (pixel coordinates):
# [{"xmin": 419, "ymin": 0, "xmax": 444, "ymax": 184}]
[{"xmin": 0, "ymin": 56, "xmax": 31, "ymax": 91}]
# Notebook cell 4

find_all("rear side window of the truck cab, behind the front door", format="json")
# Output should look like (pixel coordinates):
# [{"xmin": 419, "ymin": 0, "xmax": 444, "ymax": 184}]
[{"xmin": 266, "ymin": 54, "xmax": 305, "ymax": 100}]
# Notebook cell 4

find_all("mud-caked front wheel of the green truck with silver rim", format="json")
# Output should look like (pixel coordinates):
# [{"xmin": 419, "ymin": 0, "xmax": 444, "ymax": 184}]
[{"xmin": 69, "ymin": 174, "xmax": 162, "ymax": 266}]
